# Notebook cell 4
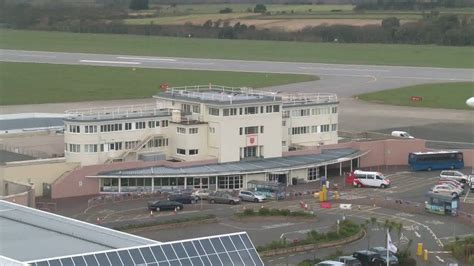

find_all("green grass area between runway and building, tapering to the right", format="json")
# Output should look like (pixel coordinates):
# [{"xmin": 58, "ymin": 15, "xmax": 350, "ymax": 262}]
[{"xmin": 0, "ymin": 62, "xmax": 317, "ymax": 105}]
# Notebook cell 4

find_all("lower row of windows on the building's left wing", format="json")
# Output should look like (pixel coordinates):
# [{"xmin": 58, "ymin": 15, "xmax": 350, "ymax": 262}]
[{"xmin": 64, "ymin": 138, "xmax": 168, "ymax": 153}]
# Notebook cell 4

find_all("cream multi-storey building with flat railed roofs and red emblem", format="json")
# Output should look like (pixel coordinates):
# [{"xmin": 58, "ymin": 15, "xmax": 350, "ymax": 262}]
[{"xmin": 64, "ymin": 85, "xmax": 338, "ymax": 165}]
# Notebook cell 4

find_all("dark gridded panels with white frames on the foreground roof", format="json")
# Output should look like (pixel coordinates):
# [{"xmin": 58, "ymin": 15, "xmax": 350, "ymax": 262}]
[{"xmin": 26, "ymin": 232, "xmax": 263, "ymax": 266}]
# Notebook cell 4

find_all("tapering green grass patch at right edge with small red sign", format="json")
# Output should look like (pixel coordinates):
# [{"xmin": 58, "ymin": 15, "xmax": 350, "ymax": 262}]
[{"xmin": 358, "ymin": 82, "xmax": 474, "ymax": 109}]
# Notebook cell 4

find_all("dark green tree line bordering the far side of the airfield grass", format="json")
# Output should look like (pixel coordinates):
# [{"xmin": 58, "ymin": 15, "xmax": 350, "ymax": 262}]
[{"xmin": 0, "ymin": 1, "xmax": 474, "ymax": 46}]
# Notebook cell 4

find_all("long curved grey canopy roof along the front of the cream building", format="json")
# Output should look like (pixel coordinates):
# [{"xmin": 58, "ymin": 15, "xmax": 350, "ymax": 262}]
[{"xmin": 96, "ymin": 148, "xmax": 365, "ymax": 177}]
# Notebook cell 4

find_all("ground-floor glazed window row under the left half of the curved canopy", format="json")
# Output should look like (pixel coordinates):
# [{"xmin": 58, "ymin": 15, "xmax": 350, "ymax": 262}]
[{"xmin": 100, "ymin": 175, "xmax": 244, "ymax": 192}]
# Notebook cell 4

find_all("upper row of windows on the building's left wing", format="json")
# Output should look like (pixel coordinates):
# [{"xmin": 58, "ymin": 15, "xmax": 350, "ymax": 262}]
[{"xmin": 66, "ymin": 120, "xmax": 169, "ymax": 134}]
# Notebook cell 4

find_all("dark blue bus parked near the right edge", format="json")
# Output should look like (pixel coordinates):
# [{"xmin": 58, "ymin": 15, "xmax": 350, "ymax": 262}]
[{"xmin": 408, "ymin": 151, "xmax": 464, "ymax": 171}]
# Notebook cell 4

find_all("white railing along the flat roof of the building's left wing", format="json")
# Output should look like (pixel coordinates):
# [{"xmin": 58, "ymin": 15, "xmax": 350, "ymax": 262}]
[{"xmin": 65, "ymin": 104, "xmax": 171, "ymax": 120}]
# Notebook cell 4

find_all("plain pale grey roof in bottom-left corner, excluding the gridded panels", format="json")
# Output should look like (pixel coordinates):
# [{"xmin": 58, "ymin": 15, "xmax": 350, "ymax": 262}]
[{"xmin": 0, "ymin": 200, "xmax": 159, "ymax": 261}]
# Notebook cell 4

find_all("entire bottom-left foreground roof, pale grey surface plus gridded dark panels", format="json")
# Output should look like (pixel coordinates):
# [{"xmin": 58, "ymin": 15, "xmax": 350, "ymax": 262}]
[{"xmin": 0, "ymin": 201, "xmax": 263, "ymax": 266}]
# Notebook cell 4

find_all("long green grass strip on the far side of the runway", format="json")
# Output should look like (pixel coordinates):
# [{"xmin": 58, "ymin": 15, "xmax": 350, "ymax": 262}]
[{"xmin": 0, "ymin": 30, "xmax": 474, "ymax": 68}]
